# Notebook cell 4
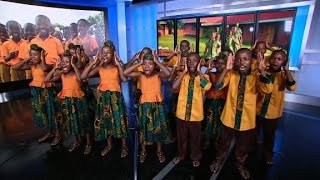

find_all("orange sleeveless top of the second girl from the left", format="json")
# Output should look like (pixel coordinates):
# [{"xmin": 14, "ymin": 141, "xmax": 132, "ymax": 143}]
[{"xmin": 58, "ymin": 74, "xmax": 84, "ymax": 99}]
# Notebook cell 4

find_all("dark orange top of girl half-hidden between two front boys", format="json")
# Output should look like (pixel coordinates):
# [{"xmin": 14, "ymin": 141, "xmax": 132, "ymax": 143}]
[{"xmin": 206, "ymin": 73, "xmax": 228, "ymax": 99}]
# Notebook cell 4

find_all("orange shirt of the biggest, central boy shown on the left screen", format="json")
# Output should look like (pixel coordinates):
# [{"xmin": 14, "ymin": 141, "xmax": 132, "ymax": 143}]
[{"xmin": 31, "ymin": 35, "xmax": 63, "ymax": 64}]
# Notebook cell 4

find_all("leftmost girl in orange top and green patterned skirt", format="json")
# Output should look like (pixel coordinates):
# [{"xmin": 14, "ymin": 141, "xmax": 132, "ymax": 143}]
[{"xmin": 12, "ymin": 44, "xmax": 58, "ymax": 143}]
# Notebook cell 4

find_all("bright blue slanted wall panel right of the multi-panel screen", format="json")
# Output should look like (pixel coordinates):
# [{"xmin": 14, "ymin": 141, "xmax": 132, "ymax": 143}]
[{"xmin": 289, "ymin": 6, "xmax": 310, "ymax": 67}]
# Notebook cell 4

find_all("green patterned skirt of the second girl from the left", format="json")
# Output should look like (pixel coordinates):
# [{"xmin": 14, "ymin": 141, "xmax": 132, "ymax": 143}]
[{"xmin": 59, "ymin": 97, "xmax": 93, "ymax": 136}]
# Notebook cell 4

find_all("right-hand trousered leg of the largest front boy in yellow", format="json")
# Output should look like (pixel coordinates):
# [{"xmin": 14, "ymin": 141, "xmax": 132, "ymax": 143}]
[{"xmin": 235, "ymin": 129, "xmax": 255, "ymax": 179}]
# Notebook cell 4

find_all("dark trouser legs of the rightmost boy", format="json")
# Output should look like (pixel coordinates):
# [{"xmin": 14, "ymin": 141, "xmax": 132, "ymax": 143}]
[{"xmin": 261, "ymin": 118, "xmax": 278, "ymax": 165}]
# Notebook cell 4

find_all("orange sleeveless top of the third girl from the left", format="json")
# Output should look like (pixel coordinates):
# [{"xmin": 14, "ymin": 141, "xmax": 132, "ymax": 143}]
[{"xmin": 97, "ymin": 67, "xmax": 121, "ymax": 92}]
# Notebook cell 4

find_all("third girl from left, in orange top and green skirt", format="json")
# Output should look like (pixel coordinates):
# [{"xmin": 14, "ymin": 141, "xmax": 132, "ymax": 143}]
[{"xmin": 81, "ymin": 41, "xmax": 128, "ymax": 158}]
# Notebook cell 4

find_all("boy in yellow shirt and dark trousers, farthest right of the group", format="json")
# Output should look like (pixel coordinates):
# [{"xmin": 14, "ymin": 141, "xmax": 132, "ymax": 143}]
[{"xmin": 257, "ymin": 50, "xmax": 296, "ymax": 165}]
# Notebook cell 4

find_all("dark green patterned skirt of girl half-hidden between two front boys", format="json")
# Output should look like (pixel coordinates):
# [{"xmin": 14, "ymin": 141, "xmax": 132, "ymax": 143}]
[{"xmin": 204, "ymin": 98, "xmax": 226, "ymax": 139}]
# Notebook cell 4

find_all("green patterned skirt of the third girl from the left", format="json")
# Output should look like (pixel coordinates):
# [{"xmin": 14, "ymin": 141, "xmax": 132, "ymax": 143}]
[{"xmin": 94, "ymin": 91, "xmax": 128, "ymax": 141}]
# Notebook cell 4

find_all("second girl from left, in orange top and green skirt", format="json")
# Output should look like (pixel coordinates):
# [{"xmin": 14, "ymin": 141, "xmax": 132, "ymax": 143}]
[{"xmin": 45, "ymin": 50, "xmax": 93, "ymax": 155}]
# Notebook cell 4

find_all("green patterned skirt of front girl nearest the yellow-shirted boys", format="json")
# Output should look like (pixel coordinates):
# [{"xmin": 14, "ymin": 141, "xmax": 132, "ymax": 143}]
[{"xmin": 139, "ymin": 102, "xmax": 170, "ymax": 145}]
